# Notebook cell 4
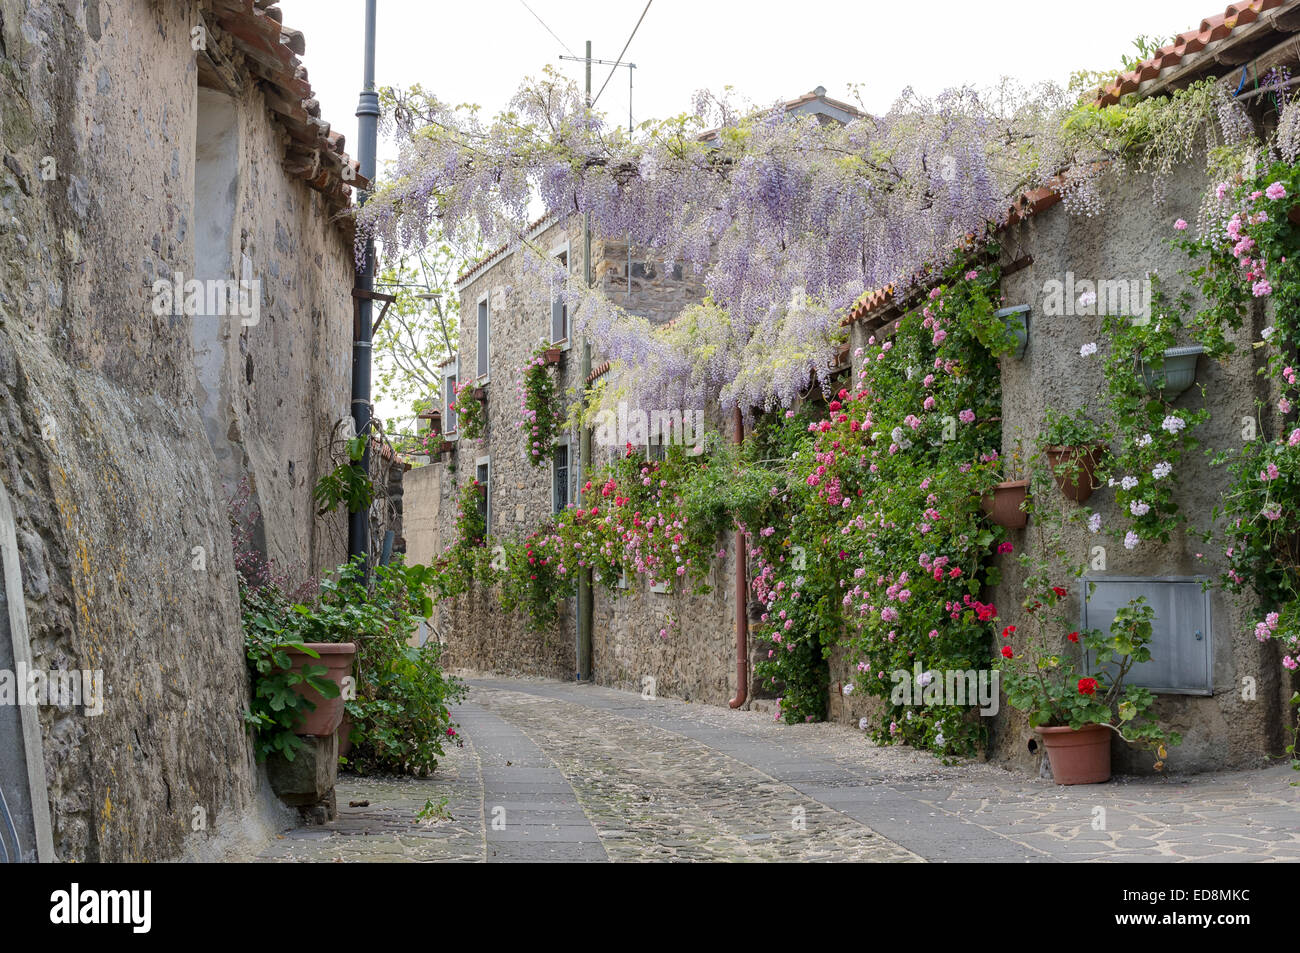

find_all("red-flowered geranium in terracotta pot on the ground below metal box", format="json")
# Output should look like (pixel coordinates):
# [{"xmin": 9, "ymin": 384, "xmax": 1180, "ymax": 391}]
[{"xmin": 996, "ymin": 576, "xmax": 1182, "ymax": 784}]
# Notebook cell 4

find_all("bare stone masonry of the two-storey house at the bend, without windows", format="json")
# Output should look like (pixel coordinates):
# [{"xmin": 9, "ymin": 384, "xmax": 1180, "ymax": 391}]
[{"xmin": 426, "ymin": 218, "xmax": 754, "ymax": 705}]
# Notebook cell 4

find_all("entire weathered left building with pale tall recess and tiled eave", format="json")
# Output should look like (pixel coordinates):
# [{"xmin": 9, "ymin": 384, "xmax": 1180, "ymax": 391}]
[{"xmin": 0, "ymin": 0, "xmax": 356, "ymax": 861}]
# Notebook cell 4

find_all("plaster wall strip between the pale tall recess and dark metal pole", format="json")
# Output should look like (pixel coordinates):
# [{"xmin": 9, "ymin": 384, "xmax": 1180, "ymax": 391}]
[{"xmin": 218, "ymin": 66, "xmax": 354, "ymax": 576}]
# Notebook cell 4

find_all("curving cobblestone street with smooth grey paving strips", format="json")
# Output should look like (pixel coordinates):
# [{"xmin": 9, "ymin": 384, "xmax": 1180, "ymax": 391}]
[{"xmin": 260, "ymin": 679, "xmax": 1300, "ymax": 862}]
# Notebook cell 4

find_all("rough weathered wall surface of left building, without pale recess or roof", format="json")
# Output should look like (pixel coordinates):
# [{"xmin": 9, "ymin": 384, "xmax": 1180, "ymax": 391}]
[{"xmin": 0, "ymin": 0, "xmax": 351, "ymax": 861}]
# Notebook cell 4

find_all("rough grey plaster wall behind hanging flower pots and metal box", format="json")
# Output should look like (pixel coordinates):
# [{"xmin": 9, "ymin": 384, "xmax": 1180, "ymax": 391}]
[{"xmin": 993, "ymin": 164, "xmax": 1282, "ymax": 771}]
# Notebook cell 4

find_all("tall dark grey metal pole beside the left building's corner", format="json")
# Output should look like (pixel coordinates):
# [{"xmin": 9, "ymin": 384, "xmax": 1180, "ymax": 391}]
[{"xmin": 347, "ymin": 0, "xmax": 380, "ymax": 559}]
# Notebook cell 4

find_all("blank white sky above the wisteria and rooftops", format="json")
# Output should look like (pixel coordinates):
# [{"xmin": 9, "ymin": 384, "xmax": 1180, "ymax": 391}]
[{"xmin": 280, "ymin": 0, "xmax": 1226, "ymax": 416}]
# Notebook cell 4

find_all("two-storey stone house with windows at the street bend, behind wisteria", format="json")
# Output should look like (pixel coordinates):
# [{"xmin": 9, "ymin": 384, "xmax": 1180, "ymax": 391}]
[{"xmin": 416, "ymin": 87, "xmax": 857, "ymax": 705}]
